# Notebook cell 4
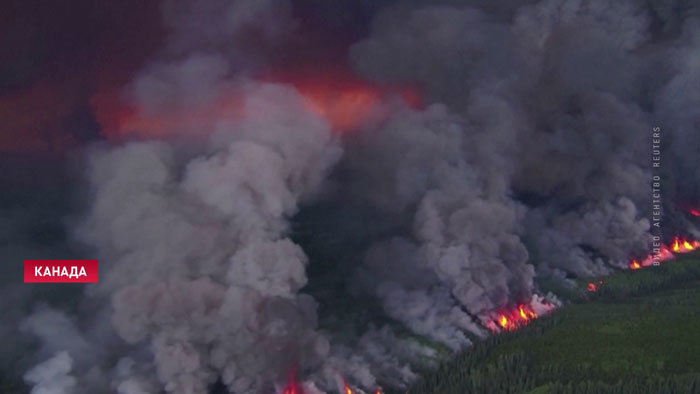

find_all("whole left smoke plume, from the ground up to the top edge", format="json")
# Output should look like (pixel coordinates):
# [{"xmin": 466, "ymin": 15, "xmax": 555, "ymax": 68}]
[{"xmin": 19, "ymin": 1, "xmax": 342, "ymax": 394}]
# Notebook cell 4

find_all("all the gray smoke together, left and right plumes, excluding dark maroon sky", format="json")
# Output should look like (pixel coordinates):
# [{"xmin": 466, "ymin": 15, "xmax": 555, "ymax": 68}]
[{"xmin": 13, "ymin": 0, "xmax": 700, "ymax": 394}]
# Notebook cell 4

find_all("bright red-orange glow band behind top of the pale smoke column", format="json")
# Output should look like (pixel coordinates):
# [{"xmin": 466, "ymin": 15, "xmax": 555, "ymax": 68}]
[{"xmin": 91, "ymin": 72, "xmax": 422, "ymax": 139}]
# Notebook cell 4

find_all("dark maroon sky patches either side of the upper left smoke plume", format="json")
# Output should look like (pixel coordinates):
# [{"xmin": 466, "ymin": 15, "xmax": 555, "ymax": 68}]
[{"xmin": 0, "ymin": 0, "xmax": 383, "ymax": 154}]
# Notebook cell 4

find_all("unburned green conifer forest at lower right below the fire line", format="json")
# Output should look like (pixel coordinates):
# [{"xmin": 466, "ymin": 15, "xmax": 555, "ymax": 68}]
[{"xmin": 408, "ymin": 253, "xmax": 700, "ymax": 394}]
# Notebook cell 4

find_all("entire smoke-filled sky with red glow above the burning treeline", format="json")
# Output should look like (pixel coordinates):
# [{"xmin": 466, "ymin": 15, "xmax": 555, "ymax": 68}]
[{"xmin": 0, "ymin": 0, "xmax": 700, "ymax": 394}]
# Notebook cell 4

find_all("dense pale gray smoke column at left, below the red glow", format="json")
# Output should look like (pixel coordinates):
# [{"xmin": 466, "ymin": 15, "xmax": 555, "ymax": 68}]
[{"xmin": 81, "ymin": 85, "xmax": 341, "ymax": 393}]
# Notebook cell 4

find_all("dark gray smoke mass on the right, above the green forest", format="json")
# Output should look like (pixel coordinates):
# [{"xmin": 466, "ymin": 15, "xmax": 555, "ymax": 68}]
[{"xmin": 345, "ymin": 0, "xmax": 698, "ymax": 356}]
